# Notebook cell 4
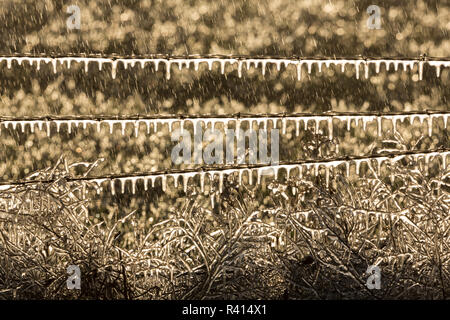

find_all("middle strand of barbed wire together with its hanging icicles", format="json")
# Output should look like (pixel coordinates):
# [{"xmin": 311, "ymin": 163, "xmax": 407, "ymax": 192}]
[{"xmin": 0, "ymin": 111, "xmax": 450, "ymax": 138}]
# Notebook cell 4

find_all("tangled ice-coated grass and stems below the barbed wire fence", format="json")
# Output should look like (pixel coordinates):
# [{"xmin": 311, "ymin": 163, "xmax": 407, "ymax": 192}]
[{"xmin": 0, "ymin": 146, "xmax": 450, "ymax": 299}]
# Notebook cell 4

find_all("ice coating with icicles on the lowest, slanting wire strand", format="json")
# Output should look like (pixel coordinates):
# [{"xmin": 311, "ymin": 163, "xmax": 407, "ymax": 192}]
[{"xmin": 79, "ymin": 151, "xmax": 450, "ymax": 195}]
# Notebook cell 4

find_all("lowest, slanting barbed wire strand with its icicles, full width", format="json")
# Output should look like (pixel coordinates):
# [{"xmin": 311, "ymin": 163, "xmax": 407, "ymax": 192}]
[{"xmin": 0, "ymin": 148, "xmax": 450, "ymax": 195}]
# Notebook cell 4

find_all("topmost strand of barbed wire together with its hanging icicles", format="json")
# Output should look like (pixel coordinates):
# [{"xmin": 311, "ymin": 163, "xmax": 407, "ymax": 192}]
[{"xmin": 0, "ymin": 54, "xmax": 450, "ymax": 81}]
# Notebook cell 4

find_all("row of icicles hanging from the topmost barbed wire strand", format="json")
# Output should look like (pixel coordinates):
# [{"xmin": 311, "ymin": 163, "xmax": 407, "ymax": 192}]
[{"xmin": 0, "ymin": 56, "xmax": 450, "ymax": 81}]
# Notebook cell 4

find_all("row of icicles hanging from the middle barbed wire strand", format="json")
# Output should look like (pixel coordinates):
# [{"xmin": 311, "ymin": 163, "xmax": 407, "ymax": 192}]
[{"xmin": 0, "ymin": 112, "xmax": 450, "ymax": 139}]
